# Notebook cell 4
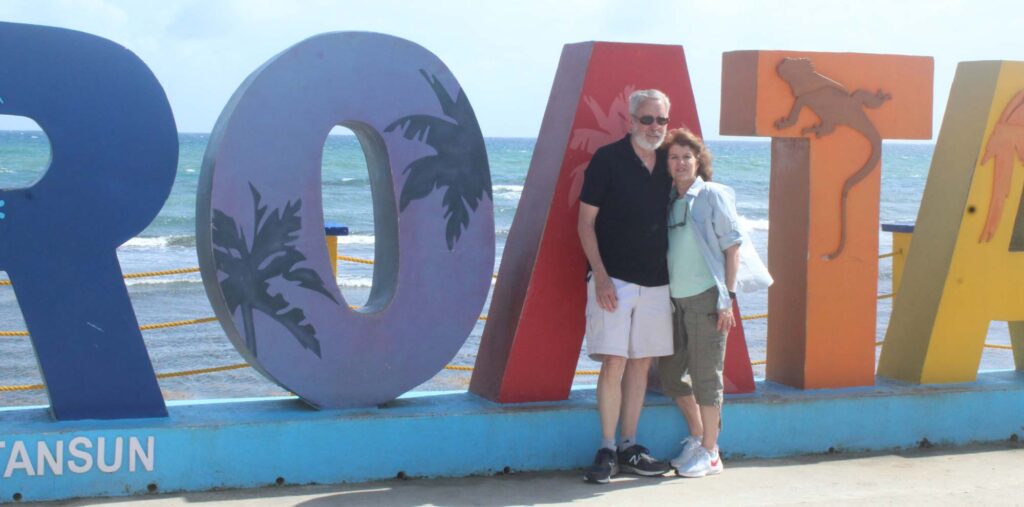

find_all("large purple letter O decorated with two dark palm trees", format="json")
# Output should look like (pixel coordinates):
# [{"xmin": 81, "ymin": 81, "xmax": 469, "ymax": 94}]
[{"xmin": 196, "ymin": 32, "xmax": 495, "ymax": 408}]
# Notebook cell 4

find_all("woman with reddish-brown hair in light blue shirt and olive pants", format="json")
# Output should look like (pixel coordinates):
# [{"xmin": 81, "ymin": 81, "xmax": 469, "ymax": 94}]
[{"xmin": 657, "ymin": 128, "xmax": 742, "ymax": 477}]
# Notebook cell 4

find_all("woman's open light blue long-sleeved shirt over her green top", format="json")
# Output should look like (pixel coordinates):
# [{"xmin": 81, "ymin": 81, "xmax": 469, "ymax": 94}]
[{"xmin": 672, "ymin": 176, "xmax": 743, "ymax": 310}]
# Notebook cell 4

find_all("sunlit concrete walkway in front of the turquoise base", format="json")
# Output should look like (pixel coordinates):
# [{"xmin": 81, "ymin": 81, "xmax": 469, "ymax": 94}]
[{"xmin": 36, "ymin": 442, "xmax": 1024, "ymax": 507}]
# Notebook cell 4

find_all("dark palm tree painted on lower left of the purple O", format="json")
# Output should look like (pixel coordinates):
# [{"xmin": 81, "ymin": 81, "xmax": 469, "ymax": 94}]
[{"xmin": 213, "ymin": 183, "xmax": 338, "ymax": 357}]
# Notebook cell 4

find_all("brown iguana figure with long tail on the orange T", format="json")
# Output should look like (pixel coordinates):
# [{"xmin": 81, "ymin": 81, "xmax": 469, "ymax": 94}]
[{"xmin": 775, "ymin": 58, "xmax": 892, "ymax": 260}]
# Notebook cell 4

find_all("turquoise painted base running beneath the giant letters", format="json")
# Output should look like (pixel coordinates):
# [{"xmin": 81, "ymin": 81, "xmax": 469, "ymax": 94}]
[{"xmin": 0, "ymin": 371, "xmax": 1024, "ymax": 502}]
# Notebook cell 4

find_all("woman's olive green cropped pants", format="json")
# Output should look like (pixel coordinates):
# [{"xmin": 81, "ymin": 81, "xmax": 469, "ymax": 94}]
[{"xmin": 657, "ymin": 287, "xmax": 726, "ymax": 407}]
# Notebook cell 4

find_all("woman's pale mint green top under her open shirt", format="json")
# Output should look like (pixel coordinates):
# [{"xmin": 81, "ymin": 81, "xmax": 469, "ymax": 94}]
[{"xmin": 669, "ymin": 195, "xmax": 715, "ymax": 298}]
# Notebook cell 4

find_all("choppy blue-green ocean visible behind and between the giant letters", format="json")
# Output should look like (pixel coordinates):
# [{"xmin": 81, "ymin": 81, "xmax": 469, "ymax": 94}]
[{"xmin": 0, "ymin": 131, "xmax": 1013, "ymax": 407}]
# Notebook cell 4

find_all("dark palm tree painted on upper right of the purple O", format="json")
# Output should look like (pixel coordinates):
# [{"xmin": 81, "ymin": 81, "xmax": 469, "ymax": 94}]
[{"xmin": 384, "ymin": 70, "xmax": 494, "ymax": 251}]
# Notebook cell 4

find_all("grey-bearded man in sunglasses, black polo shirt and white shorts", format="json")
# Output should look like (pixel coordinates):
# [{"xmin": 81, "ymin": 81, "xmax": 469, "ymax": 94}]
[{"xmin": 578, "ymin": 90, "xmax": 673, "ymax": 483}]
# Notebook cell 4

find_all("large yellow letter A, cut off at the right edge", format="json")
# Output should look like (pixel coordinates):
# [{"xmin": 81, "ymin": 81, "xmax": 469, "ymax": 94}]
[{"xmin": 879, "ymin": 61, "xmax": 1024, "ymax": 383}]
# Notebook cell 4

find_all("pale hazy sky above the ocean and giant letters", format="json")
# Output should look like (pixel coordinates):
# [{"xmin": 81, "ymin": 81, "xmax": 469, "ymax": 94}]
[{"xmin": 0, "ymin": 0, "xmax": 1024, "ymax": 139}]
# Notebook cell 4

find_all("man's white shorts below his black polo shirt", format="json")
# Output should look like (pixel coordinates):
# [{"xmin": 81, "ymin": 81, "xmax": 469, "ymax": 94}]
[{"xmin": 587, "ymin": 279, "xmax": 673, "ymax": 361}]
